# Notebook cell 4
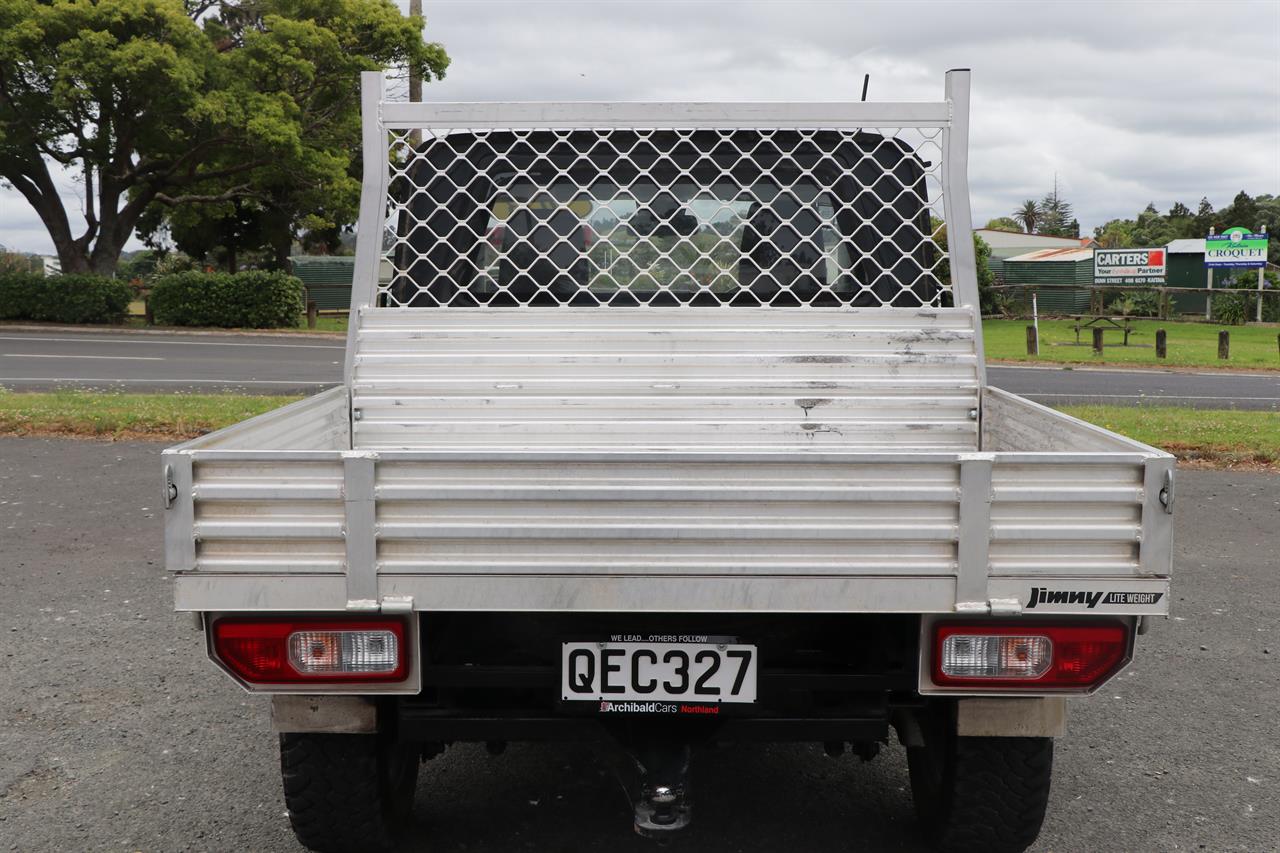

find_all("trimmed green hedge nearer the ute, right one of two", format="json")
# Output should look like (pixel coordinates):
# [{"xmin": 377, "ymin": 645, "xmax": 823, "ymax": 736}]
[{"xmin": 148, "ymin": 270, "xmax": 306, "ymax": 329}]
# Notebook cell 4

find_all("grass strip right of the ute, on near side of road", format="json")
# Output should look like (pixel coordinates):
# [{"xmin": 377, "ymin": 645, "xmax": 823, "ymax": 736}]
[{"xmin": 1060, "ymin": 406, "xmax": 1280, "ymax": 467}]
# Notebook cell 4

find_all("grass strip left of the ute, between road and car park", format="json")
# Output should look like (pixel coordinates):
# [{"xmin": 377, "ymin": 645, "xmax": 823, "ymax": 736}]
[{"xmin": 0, "ymin": 389, "xmax": 298, "ymax": 439}]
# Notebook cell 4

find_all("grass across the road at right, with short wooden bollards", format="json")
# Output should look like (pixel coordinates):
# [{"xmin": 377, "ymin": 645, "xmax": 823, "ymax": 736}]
[{"xmin": 982, "ymin": 313, "xmax": 1280, "ymax": 370}]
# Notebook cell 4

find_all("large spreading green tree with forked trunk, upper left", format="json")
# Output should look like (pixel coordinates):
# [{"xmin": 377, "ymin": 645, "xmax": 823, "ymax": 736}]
[{"xmin": 0, "ymin": 0, "xmax": 448, "ymax": 273}]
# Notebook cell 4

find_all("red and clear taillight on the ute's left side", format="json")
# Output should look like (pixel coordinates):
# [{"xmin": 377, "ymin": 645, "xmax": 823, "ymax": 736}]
[{"xmin": 212, "ymin": 619, "xmax": 408, "ymax": 684}]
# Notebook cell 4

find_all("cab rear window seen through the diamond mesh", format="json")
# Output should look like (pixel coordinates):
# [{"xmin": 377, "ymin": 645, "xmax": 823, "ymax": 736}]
[{"xmin": 472, "ymin": 179, "xmax": 855, "ymax": 304}]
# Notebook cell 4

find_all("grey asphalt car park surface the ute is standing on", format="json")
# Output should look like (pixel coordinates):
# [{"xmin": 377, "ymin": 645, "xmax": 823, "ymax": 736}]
[{"xmin": 0, "ymin": 438, "xmax": 1280, "ymax": 853}]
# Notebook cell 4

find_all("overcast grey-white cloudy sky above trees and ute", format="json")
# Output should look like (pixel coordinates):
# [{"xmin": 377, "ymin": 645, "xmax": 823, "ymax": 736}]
[{"xmin": 0, "ymin": 0, "xmax": 1280, "ymax": 252}]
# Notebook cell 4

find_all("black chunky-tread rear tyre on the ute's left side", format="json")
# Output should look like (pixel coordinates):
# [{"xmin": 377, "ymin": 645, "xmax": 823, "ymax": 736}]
[{"xmin": 280, "ymin": 734, "xmax": 417, "ymax": 853}]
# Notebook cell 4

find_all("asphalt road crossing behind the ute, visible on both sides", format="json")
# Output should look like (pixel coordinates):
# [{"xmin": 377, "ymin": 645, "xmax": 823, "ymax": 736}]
[{"xmin": 0, "ymin": 327, "xmax": 1280, "ymax": 410}]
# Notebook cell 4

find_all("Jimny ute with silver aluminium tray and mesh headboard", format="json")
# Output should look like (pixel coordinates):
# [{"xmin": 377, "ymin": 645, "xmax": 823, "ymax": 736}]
[{"xmin": 164, "ymin": 70, "xmax": 1174, "ymax": 853}]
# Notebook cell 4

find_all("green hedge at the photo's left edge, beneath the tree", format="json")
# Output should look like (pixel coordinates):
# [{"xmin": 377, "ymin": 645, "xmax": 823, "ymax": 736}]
[{"xmin": 0, "ymin": 273, "xmax": 133, "ymax": 323}]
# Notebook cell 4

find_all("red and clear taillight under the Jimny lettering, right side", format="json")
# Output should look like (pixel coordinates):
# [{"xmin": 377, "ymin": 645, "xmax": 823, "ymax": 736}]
[{"xmin": 932, "ymin": 622, "xmax": 1129, "ymax": 690}]
